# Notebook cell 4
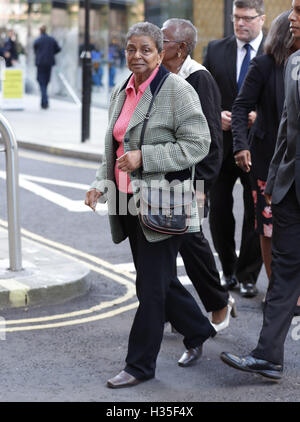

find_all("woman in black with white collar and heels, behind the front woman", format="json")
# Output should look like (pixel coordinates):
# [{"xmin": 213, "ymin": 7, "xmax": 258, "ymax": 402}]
[{"xmin": 162, "ymin": 18, "xmax": 236, "ymax": 336}]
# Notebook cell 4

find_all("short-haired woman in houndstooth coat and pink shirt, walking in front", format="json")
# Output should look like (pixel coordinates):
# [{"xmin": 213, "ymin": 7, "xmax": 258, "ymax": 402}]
[{"xmin": 85, "ymin": 22, "xmax": 216, "ymax": 388}]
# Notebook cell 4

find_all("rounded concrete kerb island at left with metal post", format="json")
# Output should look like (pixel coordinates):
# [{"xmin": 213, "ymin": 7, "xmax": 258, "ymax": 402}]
[{"xmin": 0, "ymin": 228, "xmax": 90, "ymax": 309}]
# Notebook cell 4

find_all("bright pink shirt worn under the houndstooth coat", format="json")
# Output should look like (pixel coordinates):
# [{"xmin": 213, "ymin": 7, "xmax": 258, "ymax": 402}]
[{"xmin": 113, "ymin": 67, "xmax": 159, "ymax": 193}]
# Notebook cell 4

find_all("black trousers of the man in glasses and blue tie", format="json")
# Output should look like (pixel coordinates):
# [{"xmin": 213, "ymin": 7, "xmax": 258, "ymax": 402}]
[{"xmin": 209, "ymin": 155, "xmax": 262, "ymax": 283}]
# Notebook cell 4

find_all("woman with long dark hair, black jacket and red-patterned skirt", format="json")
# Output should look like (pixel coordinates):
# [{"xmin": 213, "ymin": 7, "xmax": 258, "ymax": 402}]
[{"xmin": 232, "ymin": 11, "xmax": 299, "ymax": 314}]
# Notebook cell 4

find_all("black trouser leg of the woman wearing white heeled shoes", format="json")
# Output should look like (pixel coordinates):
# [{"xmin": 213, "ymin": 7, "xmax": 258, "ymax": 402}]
[{"xmin": 179, "ymin": 229, "xmax": 229, "ymax": 312}]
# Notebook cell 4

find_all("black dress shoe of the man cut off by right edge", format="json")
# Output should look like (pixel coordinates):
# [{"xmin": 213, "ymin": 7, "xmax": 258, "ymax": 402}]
[{"xmin": 220, "ymin": 352, "xmax": 282, "ymax": 380}]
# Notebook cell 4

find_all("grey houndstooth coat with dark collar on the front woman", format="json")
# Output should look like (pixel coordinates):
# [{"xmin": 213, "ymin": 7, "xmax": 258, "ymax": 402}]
[{"xmin": 90, "ymin": 66, "xmax": 210, "ymax": 243}]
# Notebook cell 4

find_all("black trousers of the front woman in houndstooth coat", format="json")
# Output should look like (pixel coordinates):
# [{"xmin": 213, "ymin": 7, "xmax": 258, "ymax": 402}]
[{"xmin": 120, "ymin": 211, "xmax": 215, "ymax": 379}]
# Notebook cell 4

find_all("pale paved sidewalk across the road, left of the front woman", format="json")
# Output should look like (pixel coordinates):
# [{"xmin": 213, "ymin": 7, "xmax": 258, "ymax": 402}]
[{"xmin": 0, "ymin": 95, "xmax": 108, "ymax": 161}]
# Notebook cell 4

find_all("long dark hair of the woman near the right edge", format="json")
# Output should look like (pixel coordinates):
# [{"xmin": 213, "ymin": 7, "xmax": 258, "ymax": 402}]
[{"xmin": 264, "ymin": 11, "xmax": 294, "ymax": 65}]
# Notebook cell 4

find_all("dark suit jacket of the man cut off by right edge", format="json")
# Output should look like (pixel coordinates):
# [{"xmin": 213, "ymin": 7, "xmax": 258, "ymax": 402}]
[{"xmin": 265, "ymin": 50, "xmax": 300, "ymax": 204}]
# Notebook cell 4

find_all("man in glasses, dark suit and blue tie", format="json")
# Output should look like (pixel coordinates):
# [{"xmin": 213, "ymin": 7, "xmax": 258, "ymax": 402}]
[{"xmin": 204, "ymin": 0, "xmax": 265, "ymax": 297}]
